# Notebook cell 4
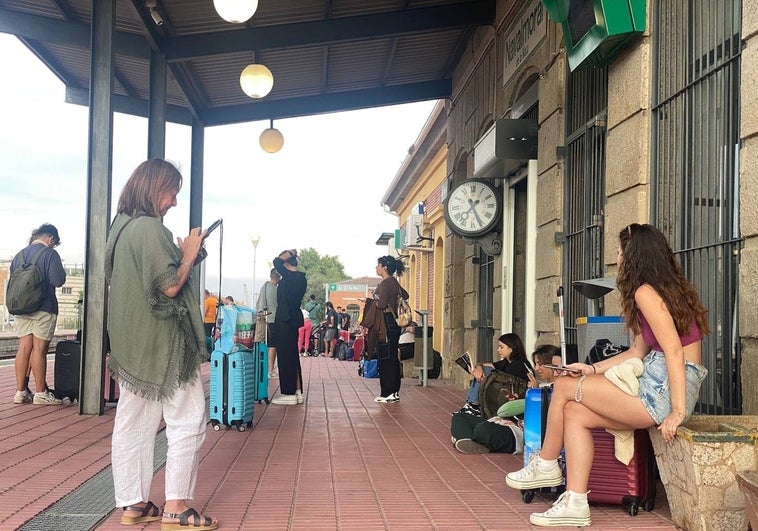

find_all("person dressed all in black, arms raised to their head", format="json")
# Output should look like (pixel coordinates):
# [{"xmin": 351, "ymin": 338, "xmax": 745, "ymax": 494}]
[{"xmin": 271, "ymin": 249, "xmax": 306, "ymax": 406}]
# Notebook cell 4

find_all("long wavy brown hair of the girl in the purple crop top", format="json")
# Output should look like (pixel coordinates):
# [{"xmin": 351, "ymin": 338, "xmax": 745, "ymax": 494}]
[{"xmin": 616, "ymin": 223, "xmax": 710, "ymax": 336}]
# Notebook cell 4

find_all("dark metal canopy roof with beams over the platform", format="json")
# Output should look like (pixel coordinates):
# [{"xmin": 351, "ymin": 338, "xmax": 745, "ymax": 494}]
[{"xmin": 0, "ymin": 0, "xmax": 495, "ymax": 126}]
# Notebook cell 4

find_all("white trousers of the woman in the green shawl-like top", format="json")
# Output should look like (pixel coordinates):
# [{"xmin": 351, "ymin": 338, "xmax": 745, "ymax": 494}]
[{"xmin": 111, "ymin": 375, "xmax": 208, "ymax": 507}]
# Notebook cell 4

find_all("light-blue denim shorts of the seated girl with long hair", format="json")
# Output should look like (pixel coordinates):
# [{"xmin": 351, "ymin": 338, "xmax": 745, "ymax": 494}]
[{"xmin": 638, "ymin": 350, "xmax": 708, "ymax": 424}]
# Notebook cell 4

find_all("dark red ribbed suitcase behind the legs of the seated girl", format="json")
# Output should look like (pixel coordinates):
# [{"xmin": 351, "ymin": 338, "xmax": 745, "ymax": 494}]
[{"xmin": 587, "ymin": 429, "xmax": 657, "ymax": 516}]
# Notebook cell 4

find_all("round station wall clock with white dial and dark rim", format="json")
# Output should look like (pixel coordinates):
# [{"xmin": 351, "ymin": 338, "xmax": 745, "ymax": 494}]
[{"xmin": 445, "ymin": 179, "xmax": 501, "ymax": 237}]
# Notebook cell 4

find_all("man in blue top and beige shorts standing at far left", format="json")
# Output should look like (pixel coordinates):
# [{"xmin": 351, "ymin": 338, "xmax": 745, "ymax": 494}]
[{"xmin": 6, "ymin": 223, "xmax": 66, "ymax": 405}]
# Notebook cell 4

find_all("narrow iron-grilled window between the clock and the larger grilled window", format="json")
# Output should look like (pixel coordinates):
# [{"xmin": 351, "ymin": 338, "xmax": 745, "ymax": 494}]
[{"xmin": 563, "ymin": 68, "xmax": 608, "ymax": 352}]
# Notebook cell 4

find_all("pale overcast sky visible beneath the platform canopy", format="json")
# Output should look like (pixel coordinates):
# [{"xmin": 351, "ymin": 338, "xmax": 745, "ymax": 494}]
[{"xmin": 0, "ymin": 34, "xmax": 434, "ymax": 298}]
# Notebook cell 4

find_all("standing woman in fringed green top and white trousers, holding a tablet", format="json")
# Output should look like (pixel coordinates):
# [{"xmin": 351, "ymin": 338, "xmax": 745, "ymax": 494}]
[{"xmin": 105, "ymin": 159, "xmax": 218, "ymax": 530}]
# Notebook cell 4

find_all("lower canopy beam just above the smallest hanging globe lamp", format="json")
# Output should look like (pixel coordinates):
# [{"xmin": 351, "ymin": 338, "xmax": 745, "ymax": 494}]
[{"xmin": 203, "ymin": 79, "xmax": 453, "ymax": 126}]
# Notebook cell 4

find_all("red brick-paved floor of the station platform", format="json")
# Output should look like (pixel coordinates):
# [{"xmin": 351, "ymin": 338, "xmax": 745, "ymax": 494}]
[{"xmin": 0, "ymin": 358, "xmax": 677, "ymax": 531}]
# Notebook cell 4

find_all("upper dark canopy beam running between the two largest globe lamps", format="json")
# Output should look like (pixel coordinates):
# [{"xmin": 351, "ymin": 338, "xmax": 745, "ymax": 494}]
[{"xmin": 165, "ymin": 0, "xmax": 495, "ymax": 63}]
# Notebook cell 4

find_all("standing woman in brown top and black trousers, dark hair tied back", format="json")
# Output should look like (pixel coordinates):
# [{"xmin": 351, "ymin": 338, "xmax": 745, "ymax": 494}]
[{"xmin": 374, "ymin": 256, "xmax": 408, "ymax": 403}]
